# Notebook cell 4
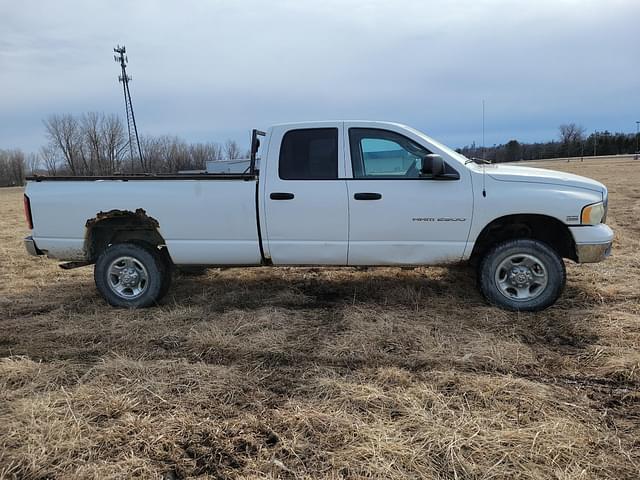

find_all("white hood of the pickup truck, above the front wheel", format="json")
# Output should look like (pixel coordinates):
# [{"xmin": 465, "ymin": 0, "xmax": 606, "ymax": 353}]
[{"xmin": 484, "ymin": 164, "xmax": 607, "ymax": 194}]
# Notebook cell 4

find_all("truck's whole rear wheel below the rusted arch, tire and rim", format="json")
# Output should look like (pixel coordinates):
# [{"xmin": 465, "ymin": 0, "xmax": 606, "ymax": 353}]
[{"xmin": 94, "ymin": 243, "xmax": 171, "ymax": 308}]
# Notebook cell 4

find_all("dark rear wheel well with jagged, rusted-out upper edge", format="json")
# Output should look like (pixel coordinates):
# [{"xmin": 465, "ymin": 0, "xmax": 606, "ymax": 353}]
[{"xmin": 85, "ymin": 208, "xmax": 168, "ymax": 262}]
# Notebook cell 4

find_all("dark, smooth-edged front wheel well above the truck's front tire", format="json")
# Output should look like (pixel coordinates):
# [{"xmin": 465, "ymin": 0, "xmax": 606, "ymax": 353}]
[{"xmin": 471, "ymin": 214, "xmax": 578, "ymax": 263}]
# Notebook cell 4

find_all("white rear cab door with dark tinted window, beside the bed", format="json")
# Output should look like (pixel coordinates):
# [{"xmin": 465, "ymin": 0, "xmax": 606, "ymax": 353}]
[{"xmin": 261, "ymin": 123, "xmax": 349, "ymax": 265}]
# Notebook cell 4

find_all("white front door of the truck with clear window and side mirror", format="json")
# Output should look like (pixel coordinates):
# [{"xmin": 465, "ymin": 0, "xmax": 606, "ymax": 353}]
[{"xmin": 345, "ymin": 124, "xmax": 473, "ymax": 265}]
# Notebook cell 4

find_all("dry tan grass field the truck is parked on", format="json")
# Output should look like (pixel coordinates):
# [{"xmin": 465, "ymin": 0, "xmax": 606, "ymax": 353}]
[{"xmin": 0, "ymin": 160, "xmax": 640, "ymax": 480}]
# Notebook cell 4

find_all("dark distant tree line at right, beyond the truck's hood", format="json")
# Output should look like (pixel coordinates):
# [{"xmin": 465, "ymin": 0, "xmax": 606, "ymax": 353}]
[{"xmin": 457, "ymin": 123, "xmax": 638, "ymax": 163}]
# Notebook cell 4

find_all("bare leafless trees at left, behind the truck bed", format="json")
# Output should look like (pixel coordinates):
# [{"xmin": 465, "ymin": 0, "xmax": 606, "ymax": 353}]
[{"xmin": 0, "ymin": 112, "xmax": 249, "ymax": 186}]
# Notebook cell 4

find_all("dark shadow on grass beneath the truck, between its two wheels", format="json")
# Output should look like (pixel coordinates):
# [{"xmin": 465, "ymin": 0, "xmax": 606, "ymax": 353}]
[{"xmin": 168, "ymin": 265, "xmax": 483, "ymax": 312}]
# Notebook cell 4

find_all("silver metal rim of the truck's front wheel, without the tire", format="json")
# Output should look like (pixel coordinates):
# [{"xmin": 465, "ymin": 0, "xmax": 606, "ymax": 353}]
[{"xmin": 495, "ymin": 253, "xmax": 549, "ymax": 302}]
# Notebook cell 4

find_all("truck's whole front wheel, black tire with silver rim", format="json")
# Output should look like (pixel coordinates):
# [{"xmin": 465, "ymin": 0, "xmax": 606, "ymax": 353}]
[{"xmin": 478, "ymin": 239, "xmax": 567, "ymax": 312}]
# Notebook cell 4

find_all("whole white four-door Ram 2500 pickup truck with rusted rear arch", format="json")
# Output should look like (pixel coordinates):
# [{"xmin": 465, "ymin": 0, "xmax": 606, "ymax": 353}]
[{"xmin": 25, "ymin": 121, "xmax": 613, "ymax": 311}]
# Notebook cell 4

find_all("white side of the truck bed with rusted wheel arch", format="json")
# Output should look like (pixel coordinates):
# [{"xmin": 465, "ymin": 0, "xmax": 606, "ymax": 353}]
[{"xmin": 25, "ymin": 174, "xmax": 261, "ymax": 265}]
